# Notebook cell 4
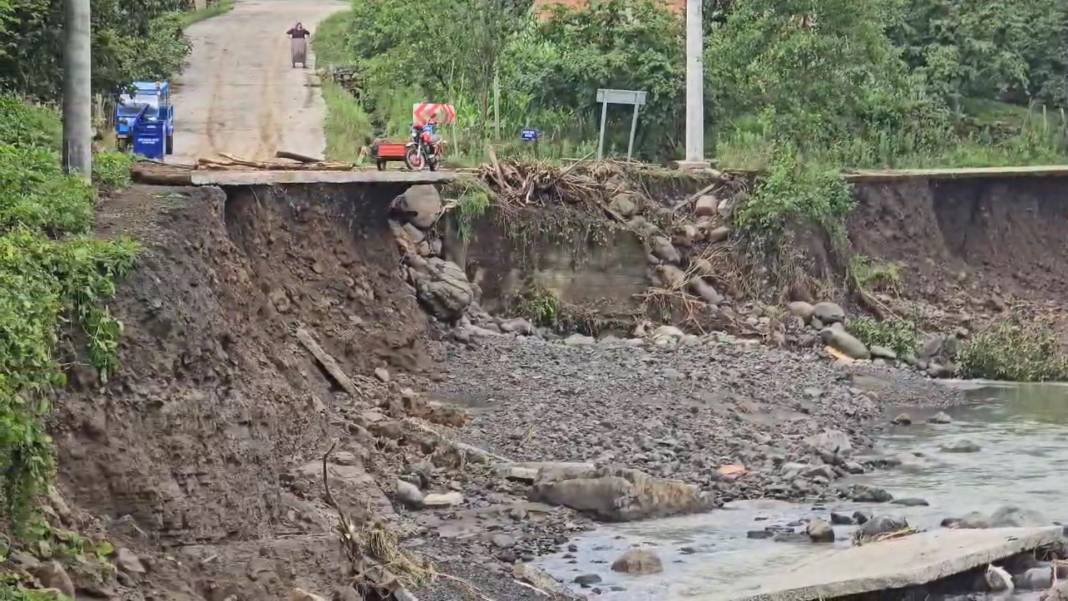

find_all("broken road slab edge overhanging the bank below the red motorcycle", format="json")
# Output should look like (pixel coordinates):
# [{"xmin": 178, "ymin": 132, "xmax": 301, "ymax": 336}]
[{"xmin": 190, "ymin": 170, "xmax": 459, "ymax": 187}]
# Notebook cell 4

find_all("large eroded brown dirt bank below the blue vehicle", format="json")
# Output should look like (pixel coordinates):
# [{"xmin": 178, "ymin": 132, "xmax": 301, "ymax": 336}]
[{"xmin": 53, "ymin": 187, "xmax": 442, "ymax": 600}]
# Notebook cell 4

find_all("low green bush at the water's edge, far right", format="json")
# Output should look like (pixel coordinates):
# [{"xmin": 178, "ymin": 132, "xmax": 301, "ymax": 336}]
[{"xmin": 957, "ymin": 321, "xmax": 1068, "ymax": 382}]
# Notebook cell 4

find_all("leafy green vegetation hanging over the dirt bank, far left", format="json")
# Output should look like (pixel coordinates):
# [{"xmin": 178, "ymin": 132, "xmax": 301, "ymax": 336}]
[{"xmin": 0, "ymin": 93, "xmax": 137, "ymax": 534}]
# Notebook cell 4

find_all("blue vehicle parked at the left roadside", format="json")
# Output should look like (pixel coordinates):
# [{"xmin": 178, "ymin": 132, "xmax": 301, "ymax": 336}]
[{"xmin": 115, "ymin": 81, "xmax": 174, "ymax": 160}]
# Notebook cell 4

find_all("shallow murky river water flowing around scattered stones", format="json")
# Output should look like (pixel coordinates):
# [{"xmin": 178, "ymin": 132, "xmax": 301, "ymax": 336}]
[{"xmin": 541, "ymin": 382, "xmax": 1068, "ymax": 601}]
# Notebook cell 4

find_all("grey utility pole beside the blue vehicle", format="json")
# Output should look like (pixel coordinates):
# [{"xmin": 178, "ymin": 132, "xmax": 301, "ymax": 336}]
[{"xmin": 63, "ymin": 0, "xmax": 93, "ymax": 177}]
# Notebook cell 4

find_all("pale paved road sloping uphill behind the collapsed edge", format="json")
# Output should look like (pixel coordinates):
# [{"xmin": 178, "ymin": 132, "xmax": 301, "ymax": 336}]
[{"xmin": 172, "ymin": 0, "xmax": 347, "ymax": 162}]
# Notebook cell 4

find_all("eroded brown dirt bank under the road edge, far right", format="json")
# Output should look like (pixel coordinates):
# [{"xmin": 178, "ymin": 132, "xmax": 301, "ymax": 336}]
[{"xmin": 848, "ymin": 177, "xmax": 1068, "ymax": 337}]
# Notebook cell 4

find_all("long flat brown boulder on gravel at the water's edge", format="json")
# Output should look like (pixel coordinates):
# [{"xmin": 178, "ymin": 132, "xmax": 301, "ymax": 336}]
[{"xmin": 531, "ymin": 468, "xmax": 713, "ymax": 522}]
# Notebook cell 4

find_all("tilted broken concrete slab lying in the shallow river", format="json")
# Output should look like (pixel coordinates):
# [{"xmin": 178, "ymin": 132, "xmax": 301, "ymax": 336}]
[{"xmin": 688, "ymin": 527, "xmax": 1064, "ymax": 601}]
